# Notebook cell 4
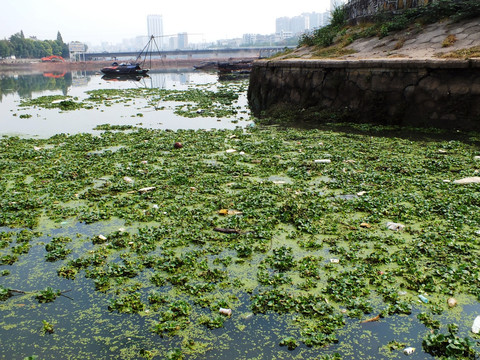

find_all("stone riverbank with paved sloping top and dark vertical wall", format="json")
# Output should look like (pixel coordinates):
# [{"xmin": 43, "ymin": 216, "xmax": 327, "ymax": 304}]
[{"xmin": 249, "ymin": 18, "xmax": 480, "ymax": 130}]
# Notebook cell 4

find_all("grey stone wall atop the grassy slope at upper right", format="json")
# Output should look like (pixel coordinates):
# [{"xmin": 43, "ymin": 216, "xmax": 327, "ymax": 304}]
[{"xmin": 346, "ymin": 0, "xmax": 434, "ymax": 23}]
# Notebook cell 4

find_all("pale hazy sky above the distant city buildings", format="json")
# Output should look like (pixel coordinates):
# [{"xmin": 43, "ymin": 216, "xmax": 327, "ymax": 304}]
[{"xmin": 0, "ymin": 0, "xmax": 330, "ymax": 45}]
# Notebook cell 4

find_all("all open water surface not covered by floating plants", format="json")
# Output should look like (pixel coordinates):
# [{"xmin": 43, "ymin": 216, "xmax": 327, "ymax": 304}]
[{"xmin": 0, "ymin": 71, "xmax": 480, "ymax": 360}]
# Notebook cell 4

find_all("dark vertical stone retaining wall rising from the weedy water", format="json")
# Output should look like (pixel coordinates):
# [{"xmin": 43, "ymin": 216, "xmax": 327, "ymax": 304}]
[{"xmin": 248, "ymin": 60, "xmax": 480, "ymax": 130}]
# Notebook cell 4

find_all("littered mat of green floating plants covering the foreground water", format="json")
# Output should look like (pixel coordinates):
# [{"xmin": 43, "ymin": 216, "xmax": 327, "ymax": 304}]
[{"xmin": 0, "ymin": 114, "xmax": 480, "ymax": 359}]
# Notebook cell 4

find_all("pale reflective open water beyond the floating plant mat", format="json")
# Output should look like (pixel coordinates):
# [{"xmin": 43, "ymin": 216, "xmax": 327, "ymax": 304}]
[{"xmin": 0, "ymin": 72, "xmax": 253, "ymax": 137}]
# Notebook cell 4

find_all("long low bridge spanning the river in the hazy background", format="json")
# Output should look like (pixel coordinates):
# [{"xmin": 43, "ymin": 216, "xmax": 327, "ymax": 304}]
[{"xmin": 85, "ymin": 46, "xmax": 294, "ymax": 61}]
